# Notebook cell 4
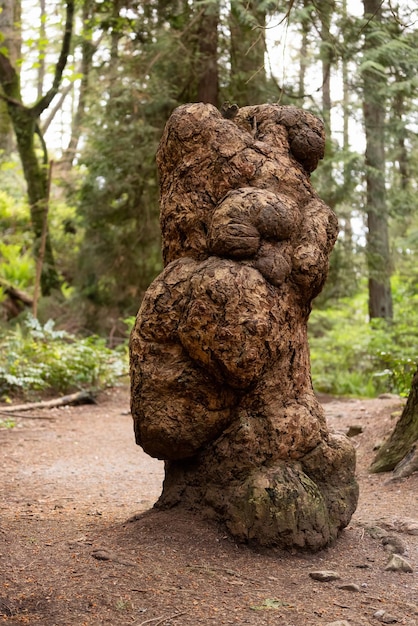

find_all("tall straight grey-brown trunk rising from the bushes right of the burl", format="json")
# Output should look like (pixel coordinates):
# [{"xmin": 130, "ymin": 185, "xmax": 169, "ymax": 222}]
[{"xmin": 363, "ymin": 0, "xmax": 393, "ymax": 320}]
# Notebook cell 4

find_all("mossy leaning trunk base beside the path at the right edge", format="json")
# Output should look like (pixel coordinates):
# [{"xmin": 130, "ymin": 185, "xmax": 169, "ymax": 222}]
[{"xmin": 370, "ymin": 372, "xmax": 418, "ymax": 472}]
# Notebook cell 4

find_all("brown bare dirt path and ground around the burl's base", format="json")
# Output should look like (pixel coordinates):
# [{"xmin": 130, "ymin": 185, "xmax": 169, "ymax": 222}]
[{"xmin": 0, "ymin": 387, "xmax": 418, "ymax": 626}]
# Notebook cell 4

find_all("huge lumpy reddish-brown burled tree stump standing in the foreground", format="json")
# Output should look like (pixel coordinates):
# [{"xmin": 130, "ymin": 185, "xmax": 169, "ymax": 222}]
[{"xmin": 131, "ymin": 104, "xmax": 358, "ymax": 550}]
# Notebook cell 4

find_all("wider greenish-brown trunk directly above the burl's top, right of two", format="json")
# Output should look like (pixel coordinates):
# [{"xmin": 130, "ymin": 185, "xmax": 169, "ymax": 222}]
[{"xmin": 229, "ymin": 0, "xmax": 266, "ymax": 106}]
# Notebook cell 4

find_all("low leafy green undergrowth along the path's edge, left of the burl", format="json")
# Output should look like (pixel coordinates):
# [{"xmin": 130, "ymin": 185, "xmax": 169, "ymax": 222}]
[{"xmin": 0, "ymin": 316, "xmax": 127, "ymax": 395}]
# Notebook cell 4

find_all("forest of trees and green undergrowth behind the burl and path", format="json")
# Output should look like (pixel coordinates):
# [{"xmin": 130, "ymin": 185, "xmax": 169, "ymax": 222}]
[{"xmin": 0, "ymin": 0, "xmax": 418, "ymax": 400}]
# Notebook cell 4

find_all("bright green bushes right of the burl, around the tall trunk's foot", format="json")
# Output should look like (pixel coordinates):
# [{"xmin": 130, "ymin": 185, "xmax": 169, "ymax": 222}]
[{"xmin": 309, "ymin": 281, "xmax": 418, "ymax": 397}]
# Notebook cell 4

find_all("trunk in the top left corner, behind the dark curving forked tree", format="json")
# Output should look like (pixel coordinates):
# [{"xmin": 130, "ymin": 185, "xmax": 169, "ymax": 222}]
[{"xmin": 0, "ymin": 0, "xmax": 22, "ymax": 157}]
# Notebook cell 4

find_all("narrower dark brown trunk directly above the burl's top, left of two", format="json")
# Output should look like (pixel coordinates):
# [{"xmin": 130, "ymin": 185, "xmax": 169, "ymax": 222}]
[{"xmin": 197, "ymin": 2, "xmax": 219, "ymax": 107}]
